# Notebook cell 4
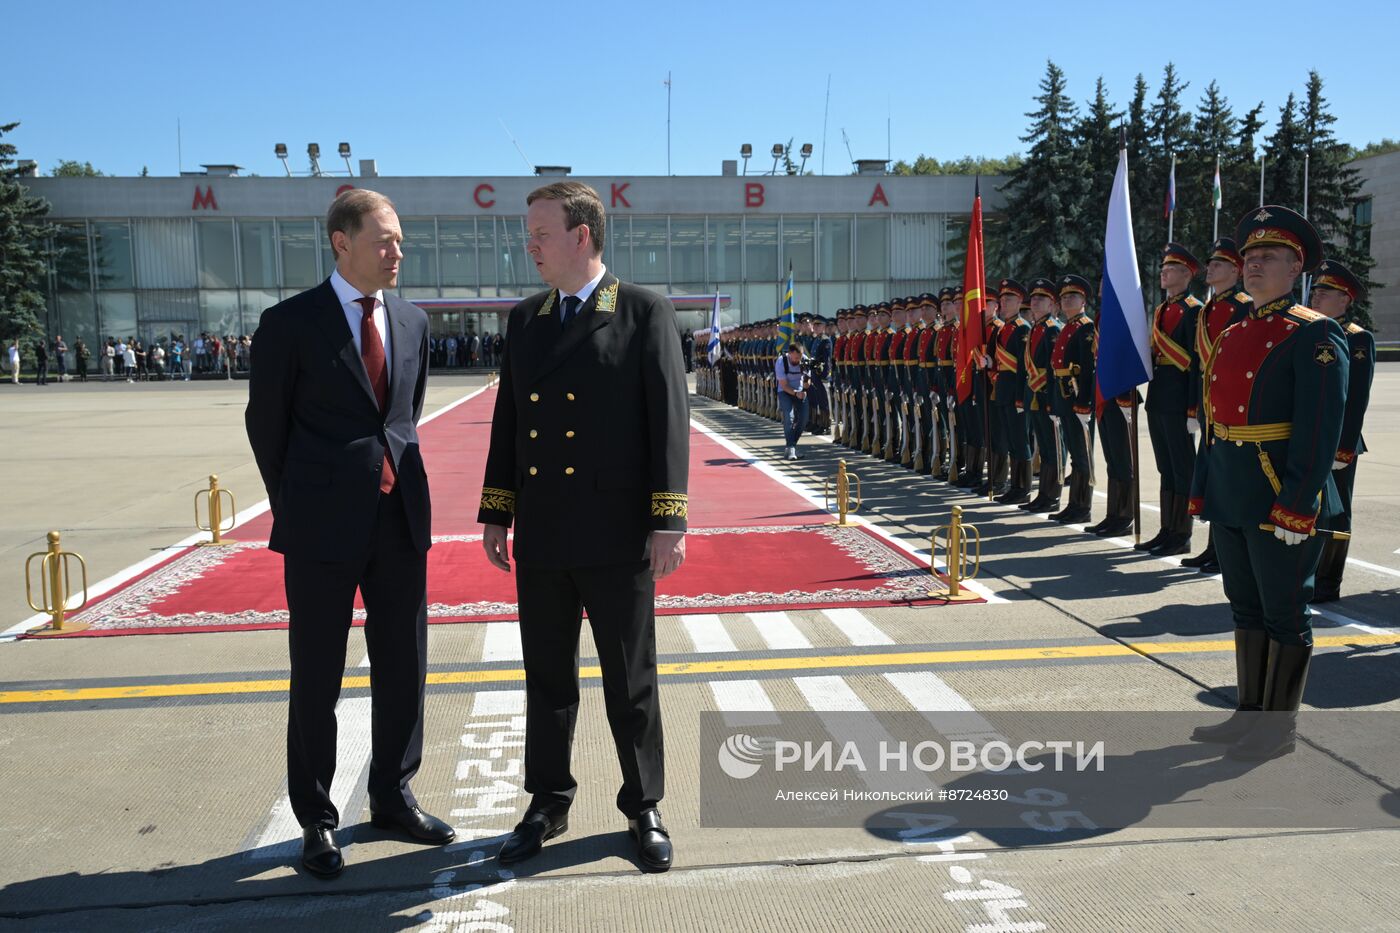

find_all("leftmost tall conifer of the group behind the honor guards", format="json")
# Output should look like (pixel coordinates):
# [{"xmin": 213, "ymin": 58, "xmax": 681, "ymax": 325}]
[{"xmin": 1004, "ymin": 60, "xmax": 1084, "ymax": 276}]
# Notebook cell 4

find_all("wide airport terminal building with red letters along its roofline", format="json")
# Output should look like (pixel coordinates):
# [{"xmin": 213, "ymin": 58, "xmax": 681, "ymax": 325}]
[{"xmin": 22, "ymin": 160, "xmax": 1004, "ymax": 345}]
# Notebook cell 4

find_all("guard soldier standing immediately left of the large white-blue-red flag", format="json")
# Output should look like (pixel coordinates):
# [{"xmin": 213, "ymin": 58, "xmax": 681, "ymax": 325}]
[{"xmin": 1050, "ymin": 275, "xmax": 1099, "ymax": 524}]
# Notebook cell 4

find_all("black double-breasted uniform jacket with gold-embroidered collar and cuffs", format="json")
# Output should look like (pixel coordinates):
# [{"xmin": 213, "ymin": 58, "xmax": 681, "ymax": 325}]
[{"xmin": 477, "ymin": 273, "xmax": 690, "ymax": 567}]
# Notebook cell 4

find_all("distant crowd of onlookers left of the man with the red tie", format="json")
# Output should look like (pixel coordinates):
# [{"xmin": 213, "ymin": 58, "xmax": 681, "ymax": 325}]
[{"xmin": 6, "ymin": 332, "xmax": 252, "ymax": 385}]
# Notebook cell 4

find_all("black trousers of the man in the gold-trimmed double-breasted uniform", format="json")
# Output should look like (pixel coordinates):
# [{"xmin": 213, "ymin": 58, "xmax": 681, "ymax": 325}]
[{"xmin": 515, "ymin": 560, "xmax": 665, "ymax": 820}]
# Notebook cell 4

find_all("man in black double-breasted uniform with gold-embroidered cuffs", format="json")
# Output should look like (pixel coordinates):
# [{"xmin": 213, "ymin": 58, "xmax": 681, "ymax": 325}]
[{"xmin": 477, "ymin": 181, "xmax": 690, "ymax": 871}]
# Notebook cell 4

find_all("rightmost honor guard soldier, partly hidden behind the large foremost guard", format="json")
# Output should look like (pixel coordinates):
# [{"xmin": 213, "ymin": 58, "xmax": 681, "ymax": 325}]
[{"xmin": 1310, "ymin": 259, "xmax": 1376, "ymax": 602}]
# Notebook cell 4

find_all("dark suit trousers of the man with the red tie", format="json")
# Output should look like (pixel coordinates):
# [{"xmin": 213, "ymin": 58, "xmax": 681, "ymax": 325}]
[{"xmin": 283, "ymin": 481, "xmax": 428, "ymax": 827}]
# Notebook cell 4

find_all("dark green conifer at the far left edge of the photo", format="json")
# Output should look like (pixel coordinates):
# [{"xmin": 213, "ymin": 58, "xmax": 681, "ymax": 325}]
[{"xmin": 0, "ymin": 123, "xmax": 53, "ymax": 353}]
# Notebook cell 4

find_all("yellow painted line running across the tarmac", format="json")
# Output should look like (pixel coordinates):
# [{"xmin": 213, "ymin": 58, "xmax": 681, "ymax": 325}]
[{"xmin": 0, "ymin": 633, "xmax": 1400, "ymax": 703}]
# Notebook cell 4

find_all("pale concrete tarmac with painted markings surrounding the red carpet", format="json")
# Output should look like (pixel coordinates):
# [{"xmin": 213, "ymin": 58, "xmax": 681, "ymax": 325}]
[{"xmin": 0, "ymin": 364, "xmax": 1400, "ymax": 933}]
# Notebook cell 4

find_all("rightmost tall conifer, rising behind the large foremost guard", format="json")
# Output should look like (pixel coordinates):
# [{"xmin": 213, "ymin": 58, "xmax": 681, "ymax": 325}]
[{"xmin": 1299, "ymin": 71, "xmax": 1376, "ymax": 328}]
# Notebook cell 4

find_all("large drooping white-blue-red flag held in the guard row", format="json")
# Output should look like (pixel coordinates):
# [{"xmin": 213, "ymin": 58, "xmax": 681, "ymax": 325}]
[{"xmin": 1095, "ymin": 148, "xmax": 1152, "ymax": 399}]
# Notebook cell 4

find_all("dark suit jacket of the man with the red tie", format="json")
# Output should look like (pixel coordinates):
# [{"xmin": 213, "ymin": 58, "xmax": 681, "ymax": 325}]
[{"xmin": 245, "ymin": 280, "xmax": 428, "ymax": 560}]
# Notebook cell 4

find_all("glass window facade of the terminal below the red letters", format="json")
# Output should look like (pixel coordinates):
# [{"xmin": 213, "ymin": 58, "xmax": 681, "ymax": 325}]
[{"xmin": 38, "ymin": 213, "xmax": 967, "ymax": 342}]
